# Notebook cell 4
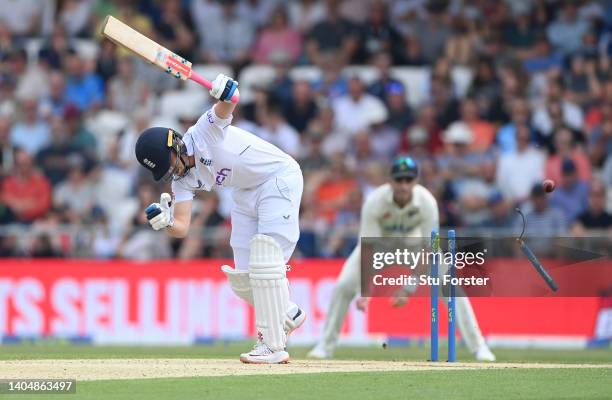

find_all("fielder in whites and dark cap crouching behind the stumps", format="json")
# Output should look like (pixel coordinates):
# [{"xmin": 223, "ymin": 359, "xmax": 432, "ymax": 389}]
[{"xmin": 308, "ymin": 157, "xmax": 495, "ymax": 361}]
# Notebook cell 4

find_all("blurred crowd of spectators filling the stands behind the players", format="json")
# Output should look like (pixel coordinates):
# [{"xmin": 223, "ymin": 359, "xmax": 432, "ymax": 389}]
[{"xmin": 0, "ymin": 0, "xmax": 612, "ymax": 259}]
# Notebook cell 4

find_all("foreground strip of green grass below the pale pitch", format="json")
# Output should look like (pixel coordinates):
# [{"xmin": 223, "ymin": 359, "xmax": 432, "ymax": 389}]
[{"xmin": 7, "ymin": 369, "xmax": 612, "ymax": 400}]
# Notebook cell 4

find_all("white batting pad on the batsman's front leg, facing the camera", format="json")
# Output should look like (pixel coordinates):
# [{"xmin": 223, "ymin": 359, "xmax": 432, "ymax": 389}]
[{"xmin": 249, "ymin": 234, "xmax": 289, "ymax": 351}]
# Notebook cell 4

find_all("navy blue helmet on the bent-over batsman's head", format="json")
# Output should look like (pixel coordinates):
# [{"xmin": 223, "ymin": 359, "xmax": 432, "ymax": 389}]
[{"xmin": 135, "ymin": 127, "xmax": 175, "ymax": 181}]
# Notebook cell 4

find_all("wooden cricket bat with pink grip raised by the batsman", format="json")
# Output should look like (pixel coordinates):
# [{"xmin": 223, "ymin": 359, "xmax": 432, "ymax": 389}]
[{"xmin": 102, "ymin": 15, "xmax": 239, "ymax": 103}]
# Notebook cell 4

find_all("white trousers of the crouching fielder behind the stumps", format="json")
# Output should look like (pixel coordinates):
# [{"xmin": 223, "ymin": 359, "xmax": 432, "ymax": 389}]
[{"xmin": 320, "ymin": 245, "xmax": 485, "ymax": 353}]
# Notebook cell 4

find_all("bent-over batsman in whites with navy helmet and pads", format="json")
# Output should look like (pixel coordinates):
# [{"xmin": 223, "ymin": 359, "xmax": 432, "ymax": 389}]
[{"xmin": 136, "ymin": 74, "xmax": 306, "ymax": 364}]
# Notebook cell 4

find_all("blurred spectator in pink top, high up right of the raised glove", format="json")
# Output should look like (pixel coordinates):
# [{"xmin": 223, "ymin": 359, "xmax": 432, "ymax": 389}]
[{"xmin": 253, "ymin": 7, "xmax": 302, "ymax": 64}]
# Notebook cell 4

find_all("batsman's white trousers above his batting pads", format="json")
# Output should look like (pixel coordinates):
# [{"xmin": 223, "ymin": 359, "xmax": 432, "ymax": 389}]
[{"xmin": 230, "ymin": 163, "xmax": 304, "ymax": 271}]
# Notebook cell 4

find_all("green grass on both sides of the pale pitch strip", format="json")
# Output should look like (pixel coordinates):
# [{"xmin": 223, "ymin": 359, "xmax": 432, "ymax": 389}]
[{"xmin": 0, "ymin": 343, "xmax": 612, "ymax": 400}]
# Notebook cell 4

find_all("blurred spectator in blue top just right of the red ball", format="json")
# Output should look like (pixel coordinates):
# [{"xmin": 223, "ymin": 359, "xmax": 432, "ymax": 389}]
[{"xmin": 550, "ymin": 158, "xmax": 589, "ymax": 224}]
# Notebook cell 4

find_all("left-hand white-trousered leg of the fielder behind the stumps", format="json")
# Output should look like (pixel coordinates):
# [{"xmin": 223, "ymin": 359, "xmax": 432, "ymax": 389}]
[{"xmin": 308, "ymin": 246, "xmax": 361, "ymax": 358}]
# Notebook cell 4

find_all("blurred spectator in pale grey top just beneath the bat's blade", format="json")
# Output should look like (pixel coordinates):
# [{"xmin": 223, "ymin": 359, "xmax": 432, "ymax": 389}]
[{"xmin": 108, "ymin": 57, "xmax": 152, "ymax": 115}]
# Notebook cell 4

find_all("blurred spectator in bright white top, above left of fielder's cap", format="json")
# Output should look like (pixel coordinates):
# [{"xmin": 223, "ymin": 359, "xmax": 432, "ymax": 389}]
[{"xmin": 332, "ymin": 76, "xmax": 388, "ymax": 134}]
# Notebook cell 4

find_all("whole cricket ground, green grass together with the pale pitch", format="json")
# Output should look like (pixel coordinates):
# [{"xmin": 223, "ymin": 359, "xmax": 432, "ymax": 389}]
[{"xmin": 0, "ymin": 343, "xmax": 612, "ymax": 400}]
